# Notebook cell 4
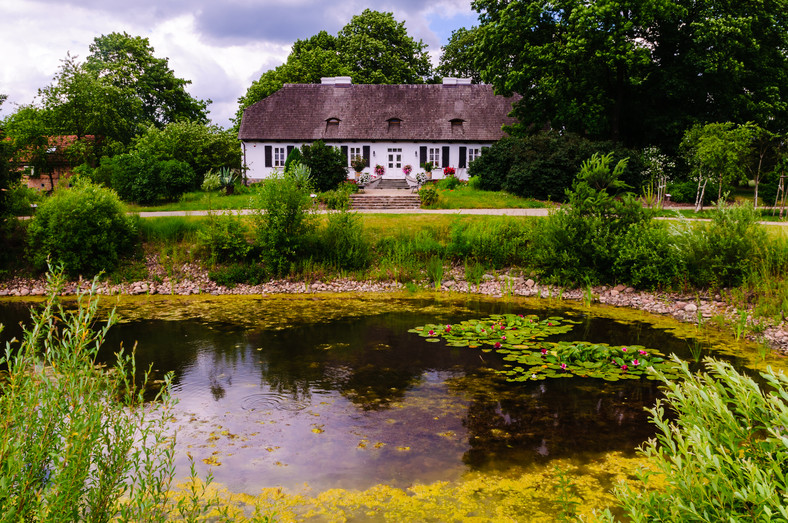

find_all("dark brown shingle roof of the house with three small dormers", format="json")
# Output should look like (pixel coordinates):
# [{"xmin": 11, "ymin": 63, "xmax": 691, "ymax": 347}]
[{"xmin": 238, "ymin": 84, "xmax": 519, "ymax": 142}]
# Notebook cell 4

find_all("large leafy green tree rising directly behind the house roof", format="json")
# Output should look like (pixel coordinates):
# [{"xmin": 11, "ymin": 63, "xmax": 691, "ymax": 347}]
[{"xmin": 234, "ymin": 9, "xmax": 432, "ymax": 130}]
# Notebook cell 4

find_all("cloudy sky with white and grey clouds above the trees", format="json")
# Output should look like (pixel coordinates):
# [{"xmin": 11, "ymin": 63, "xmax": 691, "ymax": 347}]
[{"xmin": 0, "ymin": 0, "xmax": 476, "ymax": 127}]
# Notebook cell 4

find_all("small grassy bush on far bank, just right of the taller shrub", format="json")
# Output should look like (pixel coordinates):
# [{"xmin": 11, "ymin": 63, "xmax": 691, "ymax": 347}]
[{"xmin": 319, "ymin": 212, "xmax": 371, "ymax": 271}]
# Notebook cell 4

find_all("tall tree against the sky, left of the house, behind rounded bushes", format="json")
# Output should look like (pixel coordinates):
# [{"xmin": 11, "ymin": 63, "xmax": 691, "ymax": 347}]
[{"xmin": 84, "ymin": 33, "xmax": 210, "ymax": 144}]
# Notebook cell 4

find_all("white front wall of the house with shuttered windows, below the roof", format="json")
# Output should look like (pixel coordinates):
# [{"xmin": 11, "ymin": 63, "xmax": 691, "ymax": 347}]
[{"xmin": 243, "ymin": 141, "xmax": 490, "ymax": 181}]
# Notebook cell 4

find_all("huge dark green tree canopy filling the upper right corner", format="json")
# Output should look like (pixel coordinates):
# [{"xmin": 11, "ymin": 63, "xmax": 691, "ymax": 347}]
[{"xmin": 469, "ymin": 0, "xmax": 788, "ymax": 150}]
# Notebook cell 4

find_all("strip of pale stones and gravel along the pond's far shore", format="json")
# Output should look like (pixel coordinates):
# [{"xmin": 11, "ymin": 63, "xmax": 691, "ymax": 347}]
[{"xmin": 0, "ymin": 256, "xmax": 788, "ymax": 354}]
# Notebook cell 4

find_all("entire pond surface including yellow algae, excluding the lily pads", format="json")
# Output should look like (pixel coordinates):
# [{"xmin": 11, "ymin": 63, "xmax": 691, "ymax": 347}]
[{"xmin": 0, "ymin": 294, "xmax": 776, "ymax": 520}]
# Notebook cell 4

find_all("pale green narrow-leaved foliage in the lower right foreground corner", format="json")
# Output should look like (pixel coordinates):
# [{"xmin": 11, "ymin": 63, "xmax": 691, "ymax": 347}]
[{"xmin": 607, "ymin": 358, "xmax": 788, "ymax": 521}]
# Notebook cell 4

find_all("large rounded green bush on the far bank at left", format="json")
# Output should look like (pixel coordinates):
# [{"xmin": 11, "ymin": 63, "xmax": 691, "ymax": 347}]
[{"xmin": 28, "ymin": 183, "xmax": 136, "ymax": 276}]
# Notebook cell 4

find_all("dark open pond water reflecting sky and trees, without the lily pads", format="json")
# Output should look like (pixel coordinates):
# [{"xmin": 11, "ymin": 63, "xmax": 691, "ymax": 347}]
[{"xmin": 0, "ymin": 297, "xmax": 764, "ymax": 492}]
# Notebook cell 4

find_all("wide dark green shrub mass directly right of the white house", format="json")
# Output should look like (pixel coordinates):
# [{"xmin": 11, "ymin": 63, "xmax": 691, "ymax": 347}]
[{"xmin": 468, "ymin": 132, "xmax": 641, "ymax": 200}]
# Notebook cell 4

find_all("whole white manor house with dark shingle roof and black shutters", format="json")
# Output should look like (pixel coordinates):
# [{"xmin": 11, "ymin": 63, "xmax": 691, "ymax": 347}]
[{"xmin": 238, "ymin": 77, "xmax": 519, "ymax": 181}]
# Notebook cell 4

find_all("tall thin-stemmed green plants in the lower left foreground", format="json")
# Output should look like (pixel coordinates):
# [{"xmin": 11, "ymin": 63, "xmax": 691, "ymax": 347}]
[{"xmin": 0, "ymin": 273, "xmax": 174, "ymax": 522}]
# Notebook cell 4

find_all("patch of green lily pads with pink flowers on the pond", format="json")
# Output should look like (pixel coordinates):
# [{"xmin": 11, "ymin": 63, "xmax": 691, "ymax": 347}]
[{"xmin": 408, "ymin": 314, "xmax": 677, "ymax": 382}]
